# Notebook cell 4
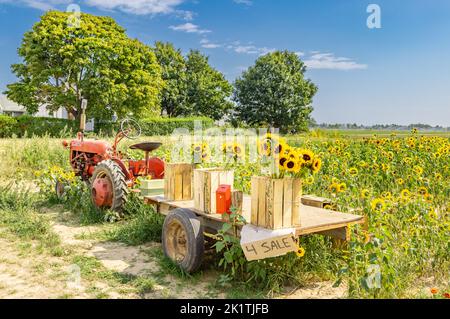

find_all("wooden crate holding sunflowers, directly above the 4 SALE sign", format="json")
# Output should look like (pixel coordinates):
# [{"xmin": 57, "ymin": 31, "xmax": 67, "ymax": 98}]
[{"xmin": 251, "ymin": 176, "xmax": 302, "ymax": 229}]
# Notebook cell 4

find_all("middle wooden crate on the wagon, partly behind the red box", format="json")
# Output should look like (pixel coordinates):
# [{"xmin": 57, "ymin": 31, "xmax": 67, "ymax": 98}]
[{"xmin": 194, "ymin": 168, "xmax": 234, "ymax": 214}]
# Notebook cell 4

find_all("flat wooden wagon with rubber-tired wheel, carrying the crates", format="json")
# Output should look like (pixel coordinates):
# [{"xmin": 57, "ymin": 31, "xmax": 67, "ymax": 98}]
[{"xmin": 144, "ymin": 195, "xmax": 367, "ymax": 272}]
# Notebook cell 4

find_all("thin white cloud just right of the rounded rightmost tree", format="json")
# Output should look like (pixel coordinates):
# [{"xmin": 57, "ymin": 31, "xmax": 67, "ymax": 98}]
[{"xmin": 303, "ymin": 51, "xmax": 368, "ymax": 71}]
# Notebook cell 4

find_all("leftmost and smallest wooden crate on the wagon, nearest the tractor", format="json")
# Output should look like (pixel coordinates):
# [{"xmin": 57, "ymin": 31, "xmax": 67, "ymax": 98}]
[{"xmin": 164, "ymin": 163, "xmax": 194, "ymax": 200}]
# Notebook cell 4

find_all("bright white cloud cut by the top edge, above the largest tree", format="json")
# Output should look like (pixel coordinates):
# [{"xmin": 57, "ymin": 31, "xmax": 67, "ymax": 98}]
[{"xmin": 85, "ymin": 0, "xmax": 185, "ymax": 15}]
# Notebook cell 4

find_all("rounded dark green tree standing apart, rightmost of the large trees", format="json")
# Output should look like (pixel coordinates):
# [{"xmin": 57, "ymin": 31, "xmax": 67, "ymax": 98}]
[{"xmin": 233, "ymin": 51, "xmax": 317, "ymax": 132}]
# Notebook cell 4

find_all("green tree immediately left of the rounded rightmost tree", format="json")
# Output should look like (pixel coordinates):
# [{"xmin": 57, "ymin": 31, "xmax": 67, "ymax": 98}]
[{"xmin": 186, "ymin": 50, "xmax": 233, "ymax": 120}]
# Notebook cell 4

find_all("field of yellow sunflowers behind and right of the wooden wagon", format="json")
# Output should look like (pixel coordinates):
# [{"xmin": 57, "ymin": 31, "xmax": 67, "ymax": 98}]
[{"xmin": 188, "ymin": 130, "xmax": 450, "ymax": 298}]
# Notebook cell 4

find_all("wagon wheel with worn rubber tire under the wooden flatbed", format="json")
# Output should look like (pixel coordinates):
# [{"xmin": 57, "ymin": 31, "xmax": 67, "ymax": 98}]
[{"xmin": 162, "ymin": 208, "xmax": 205, "ymax": 273}]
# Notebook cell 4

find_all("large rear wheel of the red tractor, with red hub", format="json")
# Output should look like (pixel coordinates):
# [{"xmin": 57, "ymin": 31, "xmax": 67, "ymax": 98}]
[{"xmin": 91, "ymin": 160, "xmax": 128, "ymax": 211}]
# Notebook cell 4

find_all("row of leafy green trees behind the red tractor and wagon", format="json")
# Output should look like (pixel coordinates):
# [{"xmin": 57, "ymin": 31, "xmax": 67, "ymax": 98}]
[{"xmin": 5, "ymin": 11, "xmax": 317, "ymax": 132}]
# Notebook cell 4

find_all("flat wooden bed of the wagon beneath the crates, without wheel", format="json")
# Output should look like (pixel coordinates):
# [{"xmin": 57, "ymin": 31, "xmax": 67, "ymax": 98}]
[{"xmin": 144, "ymin": 195, "xmax": 366, "ymax": 240}]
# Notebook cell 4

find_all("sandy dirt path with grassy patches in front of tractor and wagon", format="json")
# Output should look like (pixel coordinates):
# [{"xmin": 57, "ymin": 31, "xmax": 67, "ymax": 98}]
[{"xmin": 0, "ymin": 208, "xmax": 345, "ymax": 299}]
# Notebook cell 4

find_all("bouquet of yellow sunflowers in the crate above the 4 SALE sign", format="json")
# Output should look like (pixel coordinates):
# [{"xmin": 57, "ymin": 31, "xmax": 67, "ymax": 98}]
[{"xmin": 258, "ymin": 133, "xmax": 322, "ymax": 178}]
